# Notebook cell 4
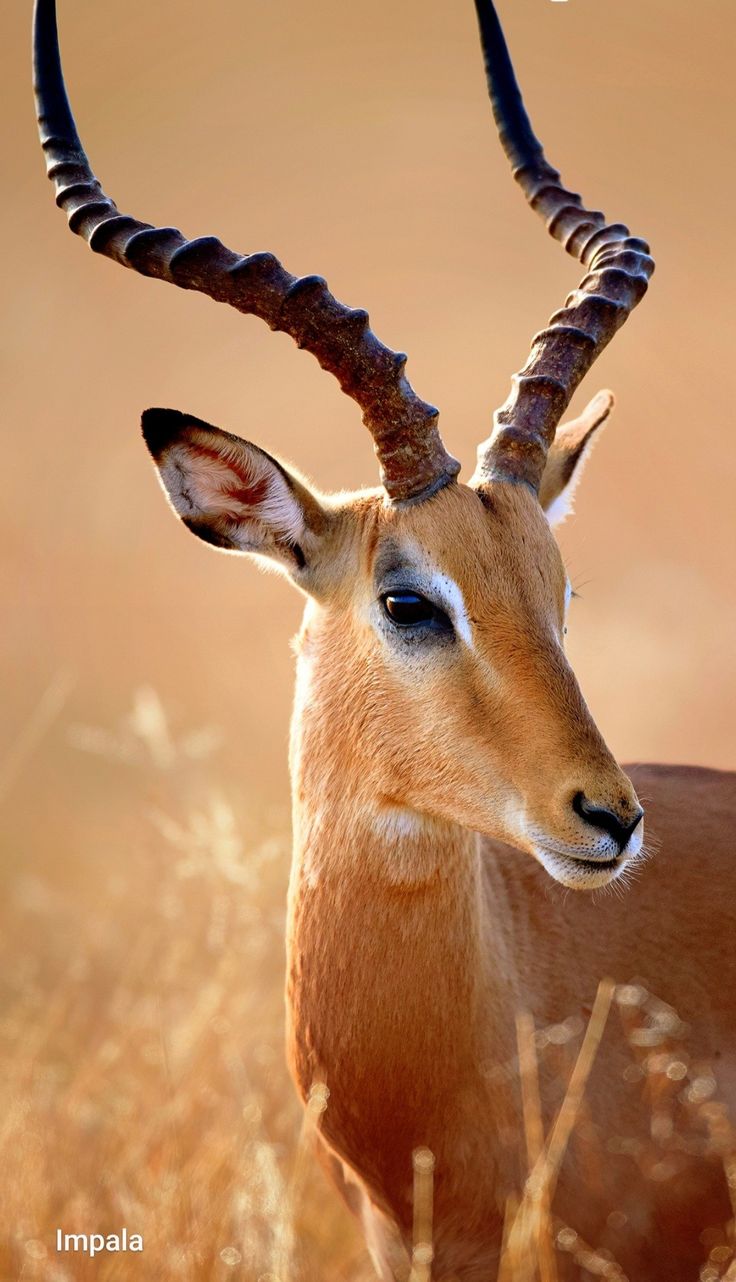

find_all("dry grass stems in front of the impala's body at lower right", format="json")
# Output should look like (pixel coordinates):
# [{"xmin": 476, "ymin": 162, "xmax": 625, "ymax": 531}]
[{"xmin": 499, "ymin": 979, "xmax": 736, "ymax": 1282}]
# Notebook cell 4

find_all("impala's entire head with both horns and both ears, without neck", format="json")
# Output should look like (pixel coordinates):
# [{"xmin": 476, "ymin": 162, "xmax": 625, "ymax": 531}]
[{"xmin": 36, "ymin": 0, "xmax": 653, "ymax": 888}]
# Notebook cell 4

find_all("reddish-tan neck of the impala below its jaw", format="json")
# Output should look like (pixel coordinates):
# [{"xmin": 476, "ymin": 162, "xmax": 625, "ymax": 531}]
[{"xmin": 289, "ymin": 633, "xmax": 523, "ymax": 1215}]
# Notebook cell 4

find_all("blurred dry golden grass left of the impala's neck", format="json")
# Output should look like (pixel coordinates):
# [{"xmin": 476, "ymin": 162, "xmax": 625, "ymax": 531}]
[{"xmin": 0, "ymin": 692, "xmax": 371, "ymax": 1282}]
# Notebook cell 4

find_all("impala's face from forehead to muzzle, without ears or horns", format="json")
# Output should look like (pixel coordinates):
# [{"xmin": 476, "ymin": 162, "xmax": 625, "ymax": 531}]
[{"xmin": 364, "ymin": 483, "xmax": 642, "ymax": 888}]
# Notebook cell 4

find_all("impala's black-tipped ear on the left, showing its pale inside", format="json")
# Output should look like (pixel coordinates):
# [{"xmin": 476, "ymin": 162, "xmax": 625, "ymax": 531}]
[{"xmin": 142, "ymin": 409, "xmax": 328, "ymax": 574}]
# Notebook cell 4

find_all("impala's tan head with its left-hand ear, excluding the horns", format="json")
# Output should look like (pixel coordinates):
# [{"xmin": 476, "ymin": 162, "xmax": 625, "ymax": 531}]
[{"xmin": 144, "ymin": 410, "xmax": 642, "ymax": 888}]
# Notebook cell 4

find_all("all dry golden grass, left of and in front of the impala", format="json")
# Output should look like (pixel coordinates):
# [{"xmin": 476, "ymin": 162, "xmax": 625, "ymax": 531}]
[{"xmin": 0, "ymin": 678, "xmax": 736, "ymax": 1282}]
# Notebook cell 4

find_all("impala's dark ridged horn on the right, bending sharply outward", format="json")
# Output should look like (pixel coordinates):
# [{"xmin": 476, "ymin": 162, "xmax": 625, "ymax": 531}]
[{"xmin": 471, "ymin": 0, "xmax": 654, "ymax": 491}]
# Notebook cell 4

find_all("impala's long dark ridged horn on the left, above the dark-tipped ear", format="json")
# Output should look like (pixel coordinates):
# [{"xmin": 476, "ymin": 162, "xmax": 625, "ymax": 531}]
[{"xmin": 33, "ymin": 0, "xmax": 459, "ymax": 501}]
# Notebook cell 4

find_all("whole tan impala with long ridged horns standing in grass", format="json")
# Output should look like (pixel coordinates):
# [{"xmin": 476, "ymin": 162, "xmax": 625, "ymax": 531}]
[{"xmin": 35, "ymin": 0, "xmax": 736, "ymax": 1282}]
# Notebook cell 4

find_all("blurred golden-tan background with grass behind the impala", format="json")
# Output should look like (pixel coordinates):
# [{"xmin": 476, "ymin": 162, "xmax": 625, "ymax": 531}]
[{"xmin": 0, "ymin": 0, "xmax": 736, "ymax": 1278}]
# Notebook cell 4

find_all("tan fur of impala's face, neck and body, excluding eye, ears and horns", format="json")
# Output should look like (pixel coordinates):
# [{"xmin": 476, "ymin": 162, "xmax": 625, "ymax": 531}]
[{"xmin": 289, "ymin": 486, "xmax": 736, "ymax": 1282}]
